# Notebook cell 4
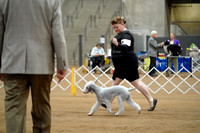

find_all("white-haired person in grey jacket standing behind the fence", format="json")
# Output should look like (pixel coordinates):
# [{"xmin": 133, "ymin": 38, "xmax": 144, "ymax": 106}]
[{"xmin": 148, "ymin": 30, "xmax": 164, "ymax": 76}]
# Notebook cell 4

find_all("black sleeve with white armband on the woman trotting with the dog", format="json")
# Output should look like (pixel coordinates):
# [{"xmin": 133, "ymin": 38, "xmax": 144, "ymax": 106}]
[{"xmin": 118, "ymin": 34, "xmax": 134, "ymax": 51}]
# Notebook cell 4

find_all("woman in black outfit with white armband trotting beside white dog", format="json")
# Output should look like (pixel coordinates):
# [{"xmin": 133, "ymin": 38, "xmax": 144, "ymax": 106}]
[{"xmin": 104, "ymin": 17, "xmax": 157, "ymax": 111}]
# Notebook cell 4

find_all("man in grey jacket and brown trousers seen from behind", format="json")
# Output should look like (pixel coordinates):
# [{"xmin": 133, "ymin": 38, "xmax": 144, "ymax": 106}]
[{"xmin": 0, "ymin": 0, "xmax": 68, "ymax": 133}]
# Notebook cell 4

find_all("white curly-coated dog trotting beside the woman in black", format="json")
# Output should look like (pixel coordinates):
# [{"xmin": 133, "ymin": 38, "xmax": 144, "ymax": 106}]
[{"xmin": 83, "ymin": 81, "xmax": 141, "ymax": 116}]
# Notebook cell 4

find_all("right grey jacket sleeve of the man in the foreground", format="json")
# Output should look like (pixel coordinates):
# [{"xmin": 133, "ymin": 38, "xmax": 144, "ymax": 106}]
[{"xmin": 52, "ymin": 0, "xmax": 69, "ymax": 70}]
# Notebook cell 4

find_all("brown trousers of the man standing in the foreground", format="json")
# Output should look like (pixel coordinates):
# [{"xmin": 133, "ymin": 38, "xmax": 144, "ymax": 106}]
[{"xmin": 3, "ymin": 74, "xmax": 52, "ymax": 133}]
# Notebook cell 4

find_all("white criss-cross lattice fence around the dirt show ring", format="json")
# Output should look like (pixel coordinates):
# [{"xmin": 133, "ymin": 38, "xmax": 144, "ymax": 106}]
[{"xmin": 52, "ymin": 59, "xmax": 200, "ymax": 94}]
